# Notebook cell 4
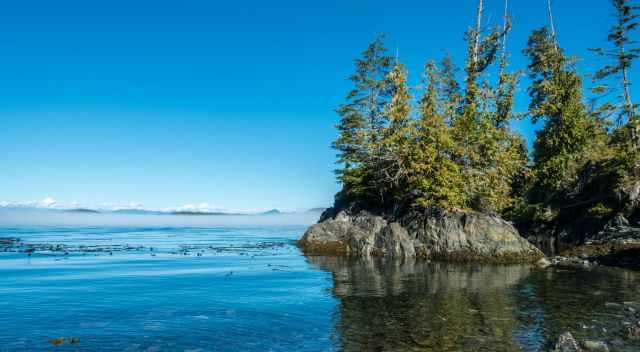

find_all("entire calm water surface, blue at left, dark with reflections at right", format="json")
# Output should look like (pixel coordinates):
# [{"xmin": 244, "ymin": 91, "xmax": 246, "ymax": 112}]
[{"xmin": 0, "ymin": 227, "xmax": 640, "ymax": 351}]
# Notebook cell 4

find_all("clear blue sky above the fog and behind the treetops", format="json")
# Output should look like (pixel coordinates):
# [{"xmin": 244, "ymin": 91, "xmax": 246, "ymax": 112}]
[{"xmin": 0, "ymin": 0, "xmax": 635, "ymax": 209}]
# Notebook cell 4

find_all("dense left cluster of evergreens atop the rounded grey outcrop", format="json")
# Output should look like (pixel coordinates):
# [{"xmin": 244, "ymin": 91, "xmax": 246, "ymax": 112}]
[{"xmin": 334, "ymin": 24, "xmax": 527, "ymax": 213}]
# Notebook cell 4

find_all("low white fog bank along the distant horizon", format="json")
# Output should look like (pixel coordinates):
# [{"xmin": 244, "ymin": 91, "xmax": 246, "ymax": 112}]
[{"xmin": 0, "ymin": 209, "xmax": 320, "ymax": 227}]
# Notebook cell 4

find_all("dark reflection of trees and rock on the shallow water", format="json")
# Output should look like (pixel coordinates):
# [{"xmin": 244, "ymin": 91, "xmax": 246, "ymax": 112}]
[{"xmin": 308, "ymin": 257, "xmax": 639, "ymax": 351}]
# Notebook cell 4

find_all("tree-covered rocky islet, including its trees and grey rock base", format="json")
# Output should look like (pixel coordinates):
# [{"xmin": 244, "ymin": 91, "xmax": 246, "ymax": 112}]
[{"xmin": 298, "ymin": 1, "xmax": 640, "ymax": 268}]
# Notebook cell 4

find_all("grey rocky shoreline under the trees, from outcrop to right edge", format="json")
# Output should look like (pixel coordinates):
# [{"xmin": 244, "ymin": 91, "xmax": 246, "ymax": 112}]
[{"xmin": 298, "ymin": 207, "xmax": 640, "ymax": 270}]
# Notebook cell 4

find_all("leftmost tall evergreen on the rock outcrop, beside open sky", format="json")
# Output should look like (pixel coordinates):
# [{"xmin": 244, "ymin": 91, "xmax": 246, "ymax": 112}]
[{"xmin": 333, "ymin": 35, "xmax": 392, "ymax": 205}]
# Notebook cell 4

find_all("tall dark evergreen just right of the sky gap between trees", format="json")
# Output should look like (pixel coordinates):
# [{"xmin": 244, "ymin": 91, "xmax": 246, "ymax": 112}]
[{"xmin": 523, "ymin": 28, "xmax": 595, "ymax": 201}]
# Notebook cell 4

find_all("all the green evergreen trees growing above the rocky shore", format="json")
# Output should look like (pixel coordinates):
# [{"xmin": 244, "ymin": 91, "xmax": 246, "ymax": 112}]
[{"xmin": 333, "ymin": 4, "xmax": 640, "ymax": 231}]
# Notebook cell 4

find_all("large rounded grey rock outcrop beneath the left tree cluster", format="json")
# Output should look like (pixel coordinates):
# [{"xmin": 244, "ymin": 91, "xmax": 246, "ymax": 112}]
[{"xmin": 299, "ymin": 209, "xmax": 543, "ymax": 262}]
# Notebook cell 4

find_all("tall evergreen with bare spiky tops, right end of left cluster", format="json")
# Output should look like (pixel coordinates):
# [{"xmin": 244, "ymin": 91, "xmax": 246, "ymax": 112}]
[{"xmin": 452, "ymin": 1, "xmax": 524, "ymax": 213}]
